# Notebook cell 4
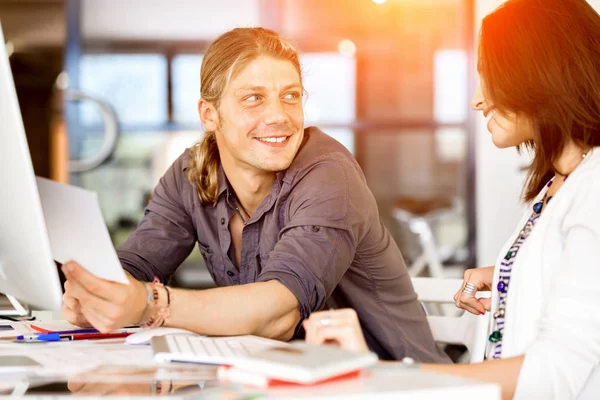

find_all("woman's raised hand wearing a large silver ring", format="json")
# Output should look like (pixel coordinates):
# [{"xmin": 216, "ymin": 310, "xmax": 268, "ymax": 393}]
[{"xmin": 454, "ymin": 266, "xmax": 495, "ymax": 315}]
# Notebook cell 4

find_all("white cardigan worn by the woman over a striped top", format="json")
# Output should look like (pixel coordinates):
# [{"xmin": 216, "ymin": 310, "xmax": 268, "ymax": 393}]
[{"xmin": 488, "ymin": 147, "xmax": 600, "ymax": 400}]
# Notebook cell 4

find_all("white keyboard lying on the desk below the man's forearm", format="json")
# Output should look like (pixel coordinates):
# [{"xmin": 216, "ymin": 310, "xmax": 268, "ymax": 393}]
[{"xmin": 152, "ymin": 335, "xmax": 287, "ymax": 365}]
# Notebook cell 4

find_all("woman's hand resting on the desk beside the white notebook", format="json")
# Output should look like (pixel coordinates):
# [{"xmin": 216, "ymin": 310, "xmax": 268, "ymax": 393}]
[{"xmin": 302, "ymin": 308, "xmax": 369, "ymax": 352}]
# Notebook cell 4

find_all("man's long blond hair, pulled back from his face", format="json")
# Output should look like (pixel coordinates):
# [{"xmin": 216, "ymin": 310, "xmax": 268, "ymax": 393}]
[{"xmin": 187, "ymin": 28, "xmax": 302, "ymax": 204}]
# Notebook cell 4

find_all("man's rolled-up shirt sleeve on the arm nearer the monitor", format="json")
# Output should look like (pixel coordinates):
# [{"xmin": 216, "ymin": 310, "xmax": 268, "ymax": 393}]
[{"xmin": 117, "ymin": 156, "xmax": 196, "ymax": 283}]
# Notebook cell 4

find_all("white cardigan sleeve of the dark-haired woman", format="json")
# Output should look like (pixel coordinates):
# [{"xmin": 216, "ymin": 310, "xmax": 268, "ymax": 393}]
[{"xmin": 514, "ymin": 176, "xmax": 600, "ymax": 399}]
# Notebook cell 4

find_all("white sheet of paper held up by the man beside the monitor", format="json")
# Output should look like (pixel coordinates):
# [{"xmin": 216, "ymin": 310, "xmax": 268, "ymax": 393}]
[{"xmin": 37, "ymin": 177, "xmax": 129, "ymax": 284}]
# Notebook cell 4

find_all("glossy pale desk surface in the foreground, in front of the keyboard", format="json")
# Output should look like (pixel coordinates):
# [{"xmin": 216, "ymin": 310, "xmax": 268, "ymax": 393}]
[{"xmin": 0, "ymin": 365, "xmax": 500, "ymax": 400}]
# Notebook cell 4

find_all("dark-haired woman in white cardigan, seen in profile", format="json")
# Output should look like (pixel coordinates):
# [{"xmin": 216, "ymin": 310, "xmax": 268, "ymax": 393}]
[{"xmin": 304, "ymin": 0, "xmax": 600, "ymax": 399}]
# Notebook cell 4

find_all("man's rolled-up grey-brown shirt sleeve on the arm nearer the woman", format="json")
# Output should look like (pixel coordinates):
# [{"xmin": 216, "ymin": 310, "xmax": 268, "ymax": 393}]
[{"xmin": 257, "ymin": 161, "xmax": 362, "ymax": 319}]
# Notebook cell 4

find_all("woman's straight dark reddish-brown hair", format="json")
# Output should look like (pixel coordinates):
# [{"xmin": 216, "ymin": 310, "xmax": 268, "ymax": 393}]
[{"xmin": 478, "ymin": 0, "xmax": 600, "ymax": 201}]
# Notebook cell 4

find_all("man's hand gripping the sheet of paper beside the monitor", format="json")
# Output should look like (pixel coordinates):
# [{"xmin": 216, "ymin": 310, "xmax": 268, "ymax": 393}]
[{"xmin": 62, "ymin": 261, "xmax": 147, "ymax": 332}]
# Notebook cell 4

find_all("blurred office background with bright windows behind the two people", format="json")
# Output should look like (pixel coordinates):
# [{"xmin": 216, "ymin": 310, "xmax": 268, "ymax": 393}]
[{"xmin": 0, "ymin": 0, "xmax": 600, "ymax": 287}]
